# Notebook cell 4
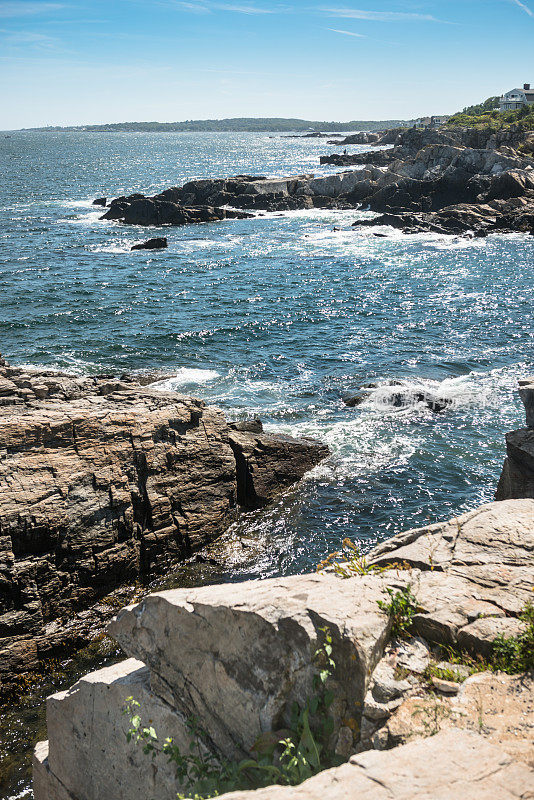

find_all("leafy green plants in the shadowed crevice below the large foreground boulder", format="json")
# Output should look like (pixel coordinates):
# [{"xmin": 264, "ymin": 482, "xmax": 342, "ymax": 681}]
[{"xmin": 123, "ymin": 628, "xmax": 340, "ymax": 800}]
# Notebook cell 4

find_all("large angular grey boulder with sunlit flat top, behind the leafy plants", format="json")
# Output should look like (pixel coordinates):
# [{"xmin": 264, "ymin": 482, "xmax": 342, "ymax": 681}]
[{"xmin": 109, "ymin": 574, "xmax": 402, "ymax": 758}]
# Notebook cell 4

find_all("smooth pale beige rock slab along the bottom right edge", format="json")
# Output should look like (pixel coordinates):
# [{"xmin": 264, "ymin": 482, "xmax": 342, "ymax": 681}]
[{"xmin": 206, "ymin": 730, "xmax": 534, "ymax": 800}]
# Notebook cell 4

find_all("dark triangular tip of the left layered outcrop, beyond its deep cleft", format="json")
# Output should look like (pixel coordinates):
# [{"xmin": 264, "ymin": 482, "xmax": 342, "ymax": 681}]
[{"xmin": 229, "ymin": 431, "xmax": 329, "ymax": 508}]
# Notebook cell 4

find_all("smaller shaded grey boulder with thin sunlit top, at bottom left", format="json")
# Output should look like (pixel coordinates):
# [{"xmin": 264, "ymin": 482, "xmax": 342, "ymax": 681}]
[{"xmin": 42, "ymin": 659, "xmax": 190, "ymax": 800}]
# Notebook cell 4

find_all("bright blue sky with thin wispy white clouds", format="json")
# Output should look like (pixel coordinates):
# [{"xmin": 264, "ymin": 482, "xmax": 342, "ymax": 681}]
[{"xmin": 0, "ymin": 0, "xmax": 534, "ymax": 129}]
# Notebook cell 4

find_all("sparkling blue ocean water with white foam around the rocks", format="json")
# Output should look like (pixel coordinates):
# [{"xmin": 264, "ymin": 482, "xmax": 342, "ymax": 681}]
[{"xmin": 0, "ymin": 132, "xmax": 534, "ymax": 797}]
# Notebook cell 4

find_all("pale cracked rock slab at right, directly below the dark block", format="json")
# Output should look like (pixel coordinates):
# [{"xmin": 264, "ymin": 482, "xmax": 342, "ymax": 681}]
[{"xmin": 369, "ymin": 500, "xmax": 534, "ymax": 649}]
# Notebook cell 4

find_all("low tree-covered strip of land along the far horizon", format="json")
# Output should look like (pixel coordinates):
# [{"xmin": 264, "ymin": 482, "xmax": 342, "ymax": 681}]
[{"xmin": 18, "ymin": 117, "xmax": 407, "ymax": 133}]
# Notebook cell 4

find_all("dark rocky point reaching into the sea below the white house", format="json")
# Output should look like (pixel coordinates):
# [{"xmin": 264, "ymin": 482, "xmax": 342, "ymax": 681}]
[{"xmin": 99, "ymin": 123, "xmax": 534, "ymax": 237}]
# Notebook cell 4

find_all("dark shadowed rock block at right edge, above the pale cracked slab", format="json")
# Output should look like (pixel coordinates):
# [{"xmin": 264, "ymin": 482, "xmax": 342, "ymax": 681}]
[{"xmin": 495, "ymin": 378, "xmax": 534, "ymax": 500}]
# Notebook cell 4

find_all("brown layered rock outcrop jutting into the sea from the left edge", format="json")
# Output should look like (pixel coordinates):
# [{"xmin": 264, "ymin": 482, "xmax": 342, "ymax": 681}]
[{"xmin": 0, "ymin": 356, "xmax": 328, "ymax": 691}]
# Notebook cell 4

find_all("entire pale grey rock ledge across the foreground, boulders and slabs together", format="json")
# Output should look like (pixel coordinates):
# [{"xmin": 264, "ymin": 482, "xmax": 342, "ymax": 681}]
[{"xmin": 34, "ymin": 499, "xmax": 534, "ymax": 800}]
